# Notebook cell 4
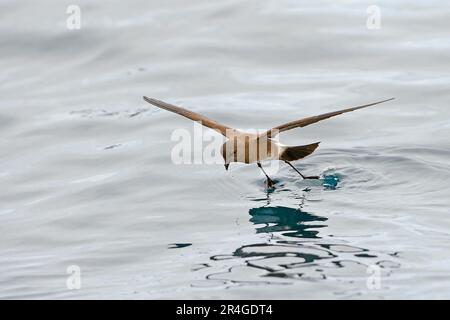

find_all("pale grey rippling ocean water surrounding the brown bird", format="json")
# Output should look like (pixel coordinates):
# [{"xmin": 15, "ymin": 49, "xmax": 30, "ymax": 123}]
[{"xmin": 0, "ymin": 0, "xmax": 450, "ymax": 299}]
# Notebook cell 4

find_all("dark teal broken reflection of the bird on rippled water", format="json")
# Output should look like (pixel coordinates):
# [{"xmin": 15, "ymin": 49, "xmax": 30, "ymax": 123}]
[{"xmin": 195, "ymin": 199, "xmax": 400, "ymax": 294}]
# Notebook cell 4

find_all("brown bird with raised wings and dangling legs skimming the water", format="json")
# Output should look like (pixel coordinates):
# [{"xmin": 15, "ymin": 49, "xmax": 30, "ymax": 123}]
[{"xmin": 144, "ymin": 96, "xmax": 394, "ymax": 187}]
